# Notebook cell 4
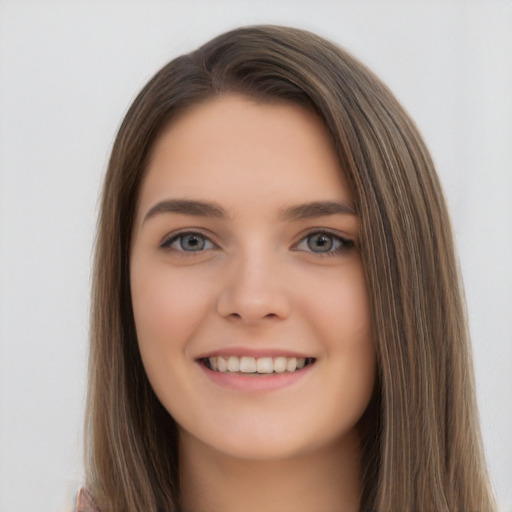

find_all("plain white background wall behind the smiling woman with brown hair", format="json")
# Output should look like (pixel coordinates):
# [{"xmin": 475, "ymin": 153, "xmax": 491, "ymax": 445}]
[{"xmin": 0, "ymin": 0, "xmax": 512, "ymax": 512}]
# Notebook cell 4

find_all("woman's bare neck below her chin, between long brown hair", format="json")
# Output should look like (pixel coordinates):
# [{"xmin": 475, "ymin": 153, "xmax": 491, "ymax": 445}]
[{"xmin": 180, "ymin": 431, "xmax": 361, "ymax": 512}]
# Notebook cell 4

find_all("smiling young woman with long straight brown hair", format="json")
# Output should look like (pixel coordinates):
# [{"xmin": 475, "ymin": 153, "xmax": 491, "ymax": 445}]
[{"xmin": 77, "ymin": 26, "xmax": 494, "ymax": 512}]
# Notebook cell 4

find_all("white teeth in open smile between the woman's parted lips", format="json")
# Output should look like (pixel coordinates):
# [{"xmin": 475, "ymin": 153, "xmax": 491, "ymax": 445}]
[{"xmin": 199, "ymin": 356, "xmax": 315, "ymax": 375}]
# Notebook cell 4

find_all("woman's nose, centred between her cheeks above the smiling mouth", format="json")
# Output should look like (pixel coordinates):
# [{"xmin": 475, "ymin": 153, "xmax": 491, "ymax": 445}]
[{"xmin": 217, "ymin": 251, "xmax": 290, "ymax": 325}]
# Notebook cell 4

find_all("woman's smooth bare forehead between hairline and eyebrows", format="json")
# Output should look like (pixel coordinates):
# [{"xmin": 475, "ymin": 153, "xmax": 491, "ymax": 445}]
[{"xmin": 136, "ymin": 94, "xmax": 351, "ymax": 214}]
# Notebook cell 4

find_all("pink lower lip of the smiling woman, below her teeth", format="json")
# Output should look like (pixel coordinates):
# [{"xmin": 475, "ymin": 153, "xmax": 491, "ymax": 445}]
[{"xmin": 199, "ymin": 363, "xmax": 314, "ymax": 391}]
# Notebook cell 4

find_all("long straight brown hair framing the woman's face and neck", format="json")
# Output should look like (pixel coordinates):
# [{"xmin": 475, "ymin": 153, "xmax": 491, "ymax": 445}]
[{"xmin": 86, "ymin": 26, "xmax": 495, "ymax": 512}]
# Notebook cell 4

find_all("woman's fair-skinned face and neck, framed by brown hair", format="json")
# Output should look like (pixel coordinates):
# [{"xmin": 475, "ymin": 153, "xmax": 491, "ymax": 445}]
[{"xmin": 130, "ymin": 95, "xmax": 375, "ymax": 512}]
